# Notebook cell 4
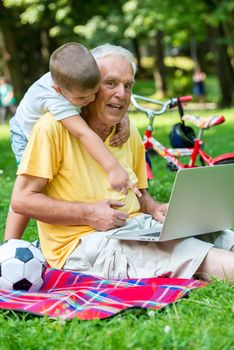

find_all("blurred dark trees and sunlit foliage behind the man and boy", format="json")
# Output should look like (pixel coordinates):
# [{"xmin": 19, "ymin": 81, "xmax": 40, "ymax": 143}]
[{"xmin": 0, "ymin": 0, "xmax": 234, "ymax": 107}]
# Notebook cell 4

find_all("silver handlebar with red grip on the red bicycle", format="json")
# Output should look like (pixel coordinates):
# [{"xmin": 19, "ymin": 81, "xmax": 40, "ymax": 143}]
[{"xmin": 131, "ymin": 94, "xmax": 192, "ymax": 116}]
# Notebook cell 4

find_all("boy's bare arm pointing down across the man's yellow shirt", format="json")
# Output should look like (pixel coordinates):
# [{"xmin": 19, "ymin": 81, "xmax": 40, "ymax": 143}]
[{"xmin": 61, "ymin": 115, "xmax": 141, "ymax": 196}]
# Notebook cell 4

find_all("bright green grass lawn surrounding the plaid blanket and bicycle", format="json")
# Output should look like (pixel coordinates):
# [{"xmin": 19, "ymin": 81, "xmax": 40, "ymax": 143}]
[{"xmin": 0, "ymin": 105, "xmax": 234, "ymax": 350}]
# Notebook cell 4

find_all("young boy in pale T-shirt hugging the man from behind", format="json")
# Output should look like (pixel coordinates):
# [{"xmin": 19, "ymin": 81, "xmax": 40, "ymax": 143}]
[{"xmin": 6, "ymin": 42, "xmax": 140, "ymax": 238}]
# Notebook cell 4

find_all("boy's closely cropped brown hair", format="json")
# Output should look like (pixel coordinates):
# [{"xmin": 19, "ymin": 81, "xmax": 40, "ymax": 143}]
[{"xmin": 49, "ymin": 42, "xmax": 100, "ymax": 91}]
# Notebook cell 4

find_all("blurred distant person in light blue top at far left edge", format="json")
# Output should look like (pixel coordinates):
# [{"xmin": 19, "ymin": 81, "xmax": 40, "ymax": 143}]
[{"xmin": 0, "ymin": 77, "xmax": 16, "ymax": 124}]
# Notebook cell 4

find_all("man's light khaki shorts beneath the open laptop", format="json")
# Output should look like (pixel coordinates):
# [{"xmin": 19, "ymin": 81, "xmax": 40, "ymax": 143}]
[{"xmin": 64, "ymin": 215, "xmax": 234, "ymax": 279}]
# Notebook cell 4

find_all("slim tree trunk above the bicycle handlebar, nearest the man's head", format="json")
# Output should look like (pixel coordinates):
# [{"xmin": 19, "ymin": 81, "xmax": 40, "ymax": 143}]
[{"xmin": 153, "ymin": 31, "xmax": 167, "ymax": 98}]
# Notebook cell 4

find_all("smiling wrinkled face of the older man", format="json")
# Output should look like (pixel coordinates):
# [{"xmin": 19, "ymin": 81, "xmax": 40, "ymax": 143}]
[{"xmin": 90, "ymin": 56, "xmax": 135, "ymax": 125}]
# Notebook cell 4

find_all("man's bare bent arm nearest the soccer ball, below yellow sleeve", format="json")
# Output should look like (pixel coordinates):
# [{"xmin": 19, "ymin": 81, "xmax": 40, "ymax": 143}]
[{"xmin": 11, "ymin": 175, "xmax": 128, "ymax": 231}]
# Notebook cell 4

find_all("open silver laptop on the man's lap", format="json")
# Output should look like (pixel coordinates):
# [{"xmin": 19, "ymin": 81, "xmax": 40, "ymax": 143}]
[{"xmin": 107, "ymin": 164, "xmax": 234, "ymax": 242}]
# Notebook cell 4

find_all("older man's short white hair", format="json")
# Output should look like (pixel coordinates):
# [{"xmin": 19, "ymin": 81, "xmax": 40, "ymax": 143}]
[{"xmin": 91, "ymin": 44, "xmax": 137, "ymax": 75}]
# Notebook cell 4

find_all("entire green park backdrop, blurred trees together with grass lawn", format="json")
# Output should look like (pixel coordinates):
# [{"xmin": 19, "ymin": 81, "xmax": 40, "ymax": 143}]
[{"xmin": 0, "ymin": 0, "xmax": 234, "ymax": 350}]
